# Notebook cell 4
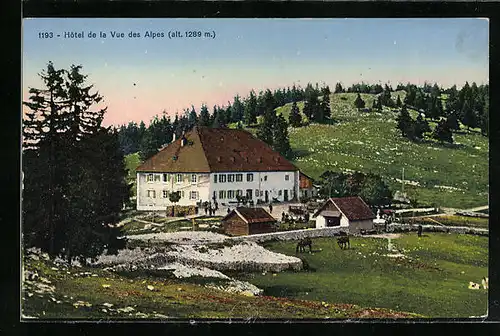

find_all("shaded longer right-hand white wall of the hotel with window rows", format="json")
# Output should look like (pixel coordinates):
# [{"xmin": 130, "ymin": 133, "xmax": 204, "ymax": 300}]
[{"xmin": 210, "ymin": 172, "xmax": 299, "ymax": 205}]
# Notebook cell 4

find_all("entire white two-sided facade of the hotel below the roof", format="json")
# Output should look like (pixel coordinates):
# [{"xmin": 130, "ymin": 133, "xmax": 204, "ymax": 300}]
[{"xmin": 137, "ymin": 171, "xmax": 300, "ymax": 210}]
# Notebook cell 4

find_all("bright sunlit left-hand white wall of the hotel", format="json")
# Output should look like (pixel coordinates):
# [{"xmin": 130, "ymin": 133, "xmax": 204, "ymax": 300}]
[{"xmin": 136, "ymin": 172, "xmax": 210, "ymax": 210}]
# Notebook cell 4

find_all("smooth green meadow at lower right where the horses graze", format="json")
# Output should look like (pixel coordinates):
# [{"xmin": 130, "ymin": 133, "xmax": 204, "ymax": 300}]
[{"xmin": 235, "ymin": 233, "xmax": 488, "ymax": 317}]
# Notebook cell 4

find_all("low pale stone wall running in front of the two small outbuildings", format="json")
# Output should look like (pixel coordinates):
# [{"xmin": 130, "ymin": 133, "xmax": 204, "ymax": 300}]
[{"xmin": 230, "ymin": 226, "xmax": 349, "ymax": 242}]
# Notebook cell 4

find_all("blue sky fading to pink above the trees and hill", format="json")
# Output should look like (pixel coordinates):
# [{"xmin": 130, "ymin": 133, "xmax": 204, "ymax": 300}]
[{"xmin": 22, "ymin": 18, "xmax": 489, "ymax": 126}]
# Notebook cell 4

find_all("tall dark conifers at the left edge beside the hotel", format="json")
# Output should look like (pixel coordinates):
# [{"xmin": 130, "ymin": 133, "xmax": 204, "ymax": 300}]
[{"xmin": 22, "ymin": 62, "xmax": 130, "ymax": 263}]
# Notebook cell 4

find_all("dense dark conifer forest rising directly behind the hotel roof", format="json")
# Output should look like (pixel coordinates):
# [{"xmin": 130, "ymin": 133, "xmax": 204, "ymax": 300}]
[{"xmin": 118, "ymin": 83, "xmax": 330, "ymax": 160}]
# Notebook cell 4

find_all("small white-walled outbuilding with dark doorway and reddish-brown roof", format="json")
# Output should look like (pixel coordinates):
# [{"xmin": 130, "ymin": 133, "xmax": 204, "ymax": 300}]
[{"xmin": 313, "ymin": 196, "xmax": 375, "ymax": 233}]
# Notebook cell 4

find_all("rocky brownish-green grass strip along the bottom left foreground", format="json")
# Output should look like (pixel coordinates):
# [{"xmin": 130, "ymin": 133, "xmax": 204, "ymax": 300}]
[{"xmin": 22, "ymin": 252, "xmax": 419, "ymax": 321}]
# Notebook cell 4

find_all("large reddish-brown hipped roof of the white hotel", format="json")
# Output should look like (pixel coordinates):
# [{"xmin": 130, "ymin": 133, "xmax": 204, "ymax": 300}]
[{"xmin": 137, "ymin": 127, "xmax": 298, "ymax": 173}]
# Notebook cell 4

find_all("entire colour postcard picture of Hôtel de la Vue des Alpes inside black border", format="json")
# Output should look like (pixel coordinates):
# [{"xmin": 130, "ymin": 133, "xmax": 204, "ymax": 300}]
[{"xmin": 20, "ymin": 18, "xmax": 489, "ymax": 322}]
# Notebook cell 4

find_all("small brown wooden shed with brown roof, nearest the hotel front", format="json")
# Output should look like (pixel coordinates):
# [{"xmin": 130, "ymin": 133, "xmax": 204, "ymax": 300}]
[{"xmin": 222, "ymin": 207, "xmax": 277, "ymax": 236}]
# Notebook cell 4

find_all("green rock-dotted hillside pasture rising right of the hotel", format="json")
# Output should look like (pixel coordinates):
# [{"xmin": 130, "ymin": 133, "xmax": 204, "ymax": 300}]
[{"xmin": 286, "ymin": 93, "xmax": 488, "ymax": 208}]
